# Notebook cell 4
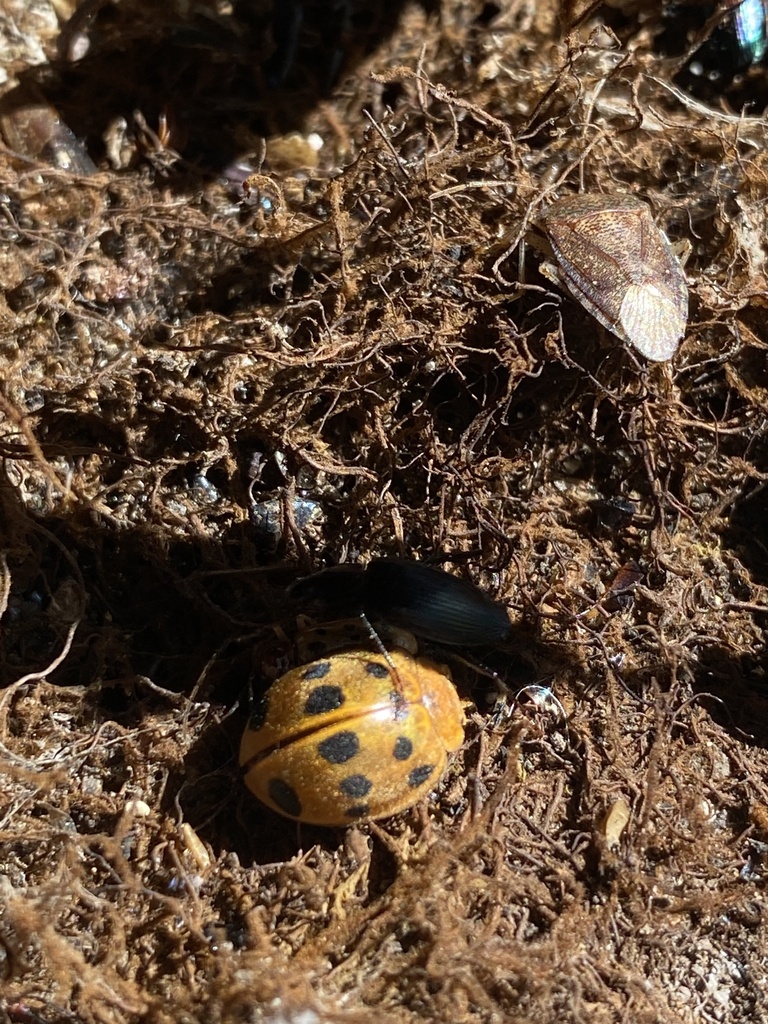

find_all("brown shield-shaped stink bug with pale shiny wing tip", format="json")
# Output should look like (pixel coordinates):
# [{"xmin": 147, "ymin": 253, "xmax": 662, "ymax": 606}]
[{"xmin": 541, "ymin": 196, "xmax": 688, "ymax": 361}]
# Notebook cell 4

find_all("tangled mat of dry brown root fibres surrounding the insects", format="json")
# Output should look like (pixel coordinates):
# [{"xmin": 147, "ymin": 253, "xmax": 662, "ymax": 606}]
[{"xmin": 0, "ymin": 0, "xmax": 768, "ymax": 1024}]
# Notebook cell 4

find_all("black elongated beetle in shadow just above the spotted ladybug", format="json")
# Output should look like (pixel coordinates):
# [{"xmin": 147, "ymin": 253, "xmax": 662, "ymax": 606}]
[{"xmin": 290, "ymin": 558, "xmax": 512, "ymax": 647}]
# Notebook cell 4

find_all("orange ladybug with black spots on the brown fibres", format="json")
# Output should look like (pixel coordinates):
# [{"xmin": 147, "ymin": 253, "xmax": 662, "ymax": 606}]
[{"xmin": 240, "ymin": 647, "xmax": 464, "ymax": 825}]
